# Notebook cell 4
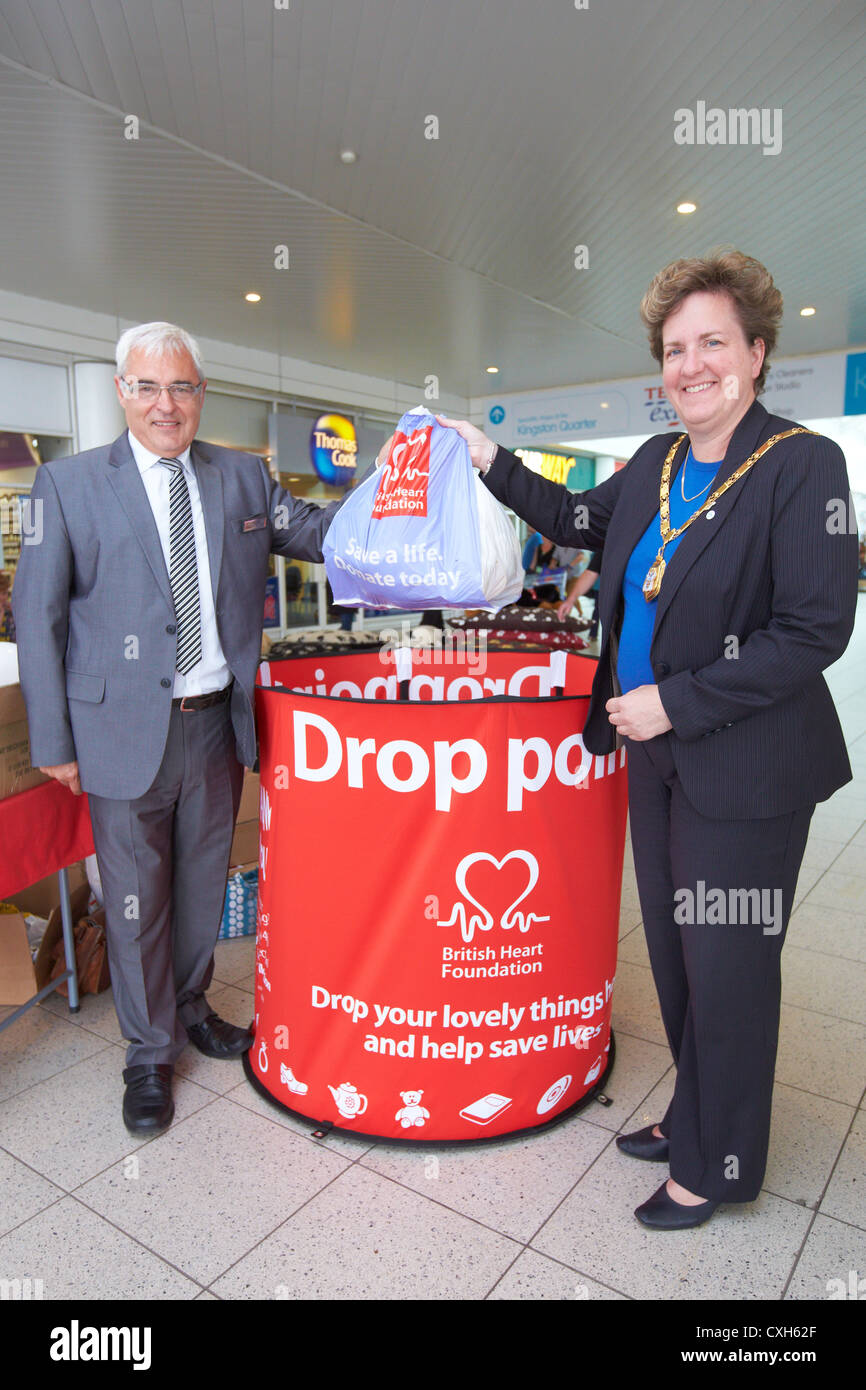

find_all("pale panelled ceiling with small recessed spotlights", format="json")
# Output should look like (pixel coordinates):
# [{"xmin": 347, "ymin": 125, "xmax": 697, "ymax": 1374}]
[{"xmin": 0, "ymin": 0, "xmax": 866, "ymax": 396}]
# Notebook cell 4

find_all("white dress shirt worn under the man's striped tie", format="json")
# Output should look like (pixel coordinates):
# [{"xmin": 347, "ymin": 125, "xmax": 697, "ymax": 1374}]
[{"xmin": 126, "ymin": 430, "xmax": 232, "ymax": 699}]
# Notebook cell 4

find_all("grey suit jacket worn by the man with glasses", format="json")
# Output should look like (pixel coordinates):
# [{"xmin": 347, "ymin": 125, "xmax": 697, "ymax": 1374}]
[{"xmin": 13, "ymin": 431, "xmax": 342, "ymax": 799}]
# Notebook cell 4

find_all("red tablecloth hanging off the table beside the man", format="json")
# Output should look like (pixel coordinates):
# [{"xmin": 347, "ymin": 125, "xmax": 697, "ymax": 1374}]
[{"xmin": 0, "ymin": 780, "xmax": 93, "ymax": 898}]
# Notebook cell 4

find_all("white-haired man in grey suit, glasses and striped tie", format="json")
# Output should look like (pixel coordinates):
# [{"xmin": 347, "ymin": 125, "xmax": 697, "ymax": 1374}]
[{"xmin": 14, "ymin": 322, "xmax": 341, "ymax": 1134}]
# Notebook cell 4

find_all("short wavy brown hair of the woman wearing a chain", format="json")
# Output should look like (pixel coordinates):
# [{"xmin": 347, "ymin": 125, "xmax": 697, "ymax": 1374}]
[{"xmin": 641, "ymin": 249, "xmax": 783, "ymax": 395}]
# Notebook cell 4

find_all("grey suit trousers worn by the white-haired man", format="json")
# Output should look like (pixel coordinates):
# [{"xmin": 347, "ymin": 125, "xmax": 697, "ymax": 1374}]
[{"xmin": 89, "ymin": 701, "xmax": 243, "ymax": 1066}]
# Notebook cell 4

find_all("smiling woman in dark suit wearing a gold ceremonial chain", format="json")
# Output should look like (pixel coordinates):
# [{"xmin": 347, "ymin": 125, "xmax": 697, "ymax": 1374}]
[{"xmin": 439, "ymin": 252, "xmax": 858, "ymax": 1230}]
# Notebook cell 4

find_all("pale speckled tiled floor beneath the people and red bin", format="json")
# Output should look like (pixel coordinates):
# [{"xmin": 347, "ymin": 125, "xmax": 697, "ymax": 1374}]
[{"xmin": 0, "ymin": 595, "xmax": 866, "ymax": 1300}]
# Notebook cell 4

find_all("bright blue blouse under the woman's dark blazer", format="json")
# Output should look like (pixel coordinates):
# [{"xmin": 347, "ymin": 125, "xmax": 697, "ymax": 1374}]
[{"xmin": 617, "ymin": 449, "xmax": 721, "ymax": 695}]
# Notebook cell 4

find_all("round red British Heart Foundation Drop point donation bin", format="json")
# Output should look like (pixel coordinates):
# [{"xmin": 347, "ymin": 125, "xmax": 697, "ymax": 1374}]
[{"xmin": 245, "ymin": 648, "xmax": 627, "ymax": 1143}]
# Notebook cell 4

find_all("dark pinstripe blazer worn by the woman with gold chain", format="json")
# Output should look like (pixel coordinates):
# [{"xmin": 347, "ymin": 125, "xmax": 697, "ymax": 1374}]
[{"xmin": 484, "ymin": 400, "xmax": 858, "ymax": 820}]
